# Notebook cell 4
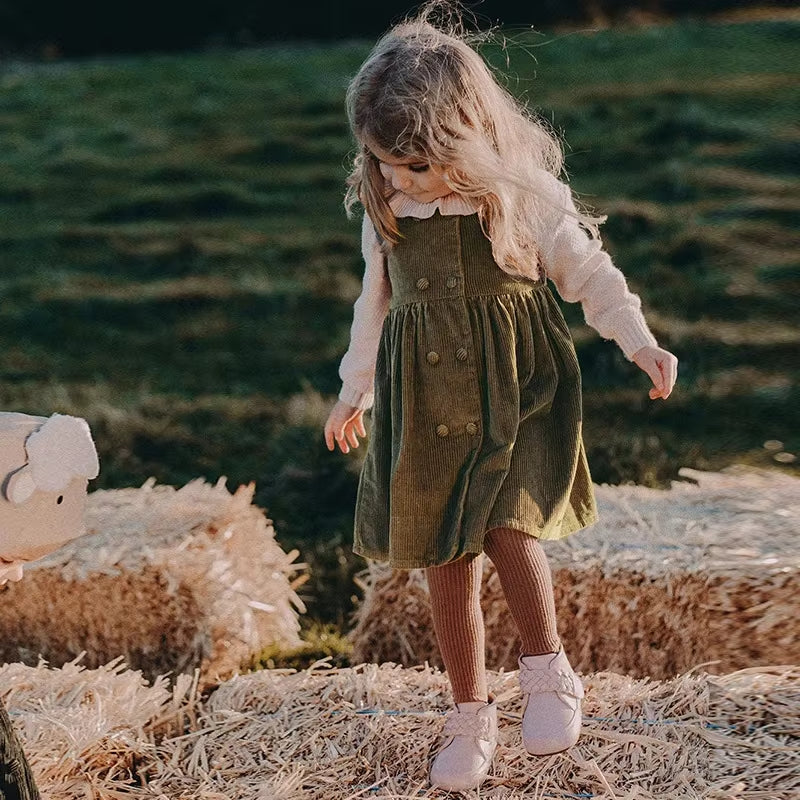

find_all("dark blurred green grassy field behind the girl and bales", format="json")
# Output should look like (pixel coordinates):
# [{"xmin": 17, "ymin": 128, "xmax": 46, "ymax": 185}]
[{"xmin": 0, "ymin": 0, "xmax": 800, "ymax": 644}]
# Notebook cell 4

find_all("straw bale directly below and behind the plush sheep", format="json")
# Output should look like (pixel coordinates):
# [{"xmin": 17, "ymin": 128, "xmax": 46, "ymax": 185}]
[{"xmin": 0, "ymin": 478, "xmax": 307, "ymax": 685}]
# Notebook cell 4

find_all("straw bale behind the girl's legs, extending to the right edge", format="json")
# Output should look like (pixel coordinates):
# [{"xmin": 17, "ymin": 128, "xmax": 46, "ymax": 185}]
[{"xmin": 349, "ymin": 465, "xmax": 800, "ymax": 678}]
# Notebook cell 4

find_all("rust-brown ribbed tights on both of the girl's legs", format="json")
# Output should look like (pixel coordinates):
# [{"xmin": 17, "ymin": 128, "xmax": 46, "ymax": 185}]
[{"xmin": 425, "ymin": 528, "xmax": 561, "ymax": 703}]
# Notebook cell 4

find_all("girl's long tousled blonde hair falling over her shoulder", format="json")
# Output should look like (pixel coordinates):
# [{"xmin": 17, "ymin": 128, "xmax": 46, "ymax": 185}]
[{"xmin": 344, "ymin": 0, "xmax": 606, "ymax": 275}]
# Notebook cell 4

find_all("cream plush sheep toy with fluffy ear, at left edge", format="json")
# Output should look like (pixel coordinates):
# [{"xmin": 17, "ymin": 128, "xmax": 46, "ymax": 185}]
[{"xmin": 0, "ymin": 412, "xmax": 100, "ymax": 583}]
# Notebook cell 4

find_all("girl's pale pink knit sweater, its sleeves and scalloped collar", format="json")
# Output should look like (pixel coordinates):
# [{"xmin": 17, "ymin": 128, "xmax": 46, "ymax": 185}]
[{"xmin": 339, "ymin": 181, "xmax": 657, "ymax": 409}]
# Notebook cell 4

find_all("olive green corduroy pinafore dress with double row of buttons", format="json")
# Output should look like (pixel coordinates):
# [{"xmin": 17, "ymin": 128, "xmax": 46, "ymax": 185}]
[{"xmin": 353, "ymin": 210, "xmax": 598, "ymax": 569}]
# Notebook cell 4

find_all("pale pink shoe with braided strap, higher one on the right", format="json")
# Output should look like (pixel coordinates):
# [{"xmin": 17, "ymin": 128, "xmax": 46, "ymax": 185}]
[{"xmin": 518, "ymin": 647, "xmax": 584, "ymax": 756}]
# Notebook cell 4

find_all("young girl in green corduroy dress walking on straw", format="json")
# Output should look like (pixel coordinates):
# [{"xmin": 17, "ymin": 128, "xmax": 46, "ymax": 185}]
[{"xmin": 325, "ymin": 8, "xmax": 677, "ymax": 790}]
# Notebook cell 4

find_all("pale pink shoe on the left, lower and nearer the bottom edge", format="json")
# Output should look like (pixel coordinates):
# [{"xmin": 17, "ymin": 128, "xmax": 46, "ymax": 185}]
[{"xmin": 430, "ymin": 695, "xmax": 497, "ymax": 791}]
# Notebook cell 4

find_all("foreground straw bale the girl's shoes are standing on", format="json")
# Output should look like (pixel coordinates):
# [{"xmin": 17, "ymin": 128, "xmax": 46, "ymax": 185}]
[{"xmin": 148, "ymin": 663, "xmax": 800, "ymax": 800}]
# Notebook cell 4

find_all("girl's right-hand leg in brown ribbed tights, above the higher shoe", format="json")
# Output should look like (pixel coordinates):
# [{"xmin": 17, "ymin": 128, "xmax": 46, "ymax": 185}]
[{"xmin": 483, "ymin": 528, "xmax": 561, "ymax": 655}]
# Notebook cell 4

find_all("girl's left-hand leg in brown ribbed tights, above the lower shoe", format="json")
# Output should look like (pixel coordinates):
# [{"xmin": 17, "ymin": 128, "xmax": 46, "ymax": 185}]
[{"xmin": 425, "ymin": 553, "xmax": 488, "ymax": 703}]
